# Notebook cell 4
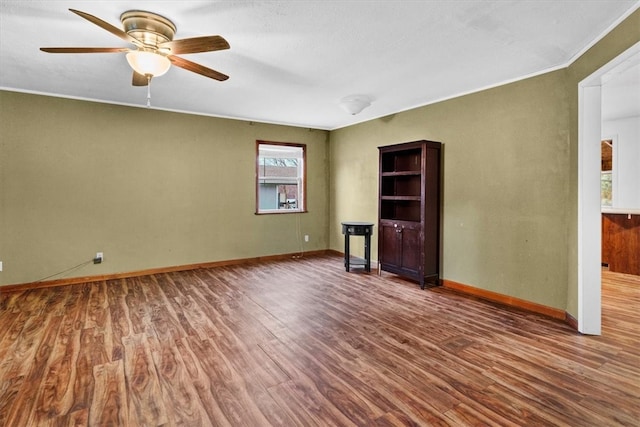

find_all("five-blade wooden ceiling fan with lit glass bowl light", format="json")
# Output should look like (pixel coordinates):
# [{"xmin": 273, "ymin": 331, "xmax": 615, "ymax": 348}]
[{"xmin": 40, "ymin": 9, "xmax": 229, "ymax": 86}]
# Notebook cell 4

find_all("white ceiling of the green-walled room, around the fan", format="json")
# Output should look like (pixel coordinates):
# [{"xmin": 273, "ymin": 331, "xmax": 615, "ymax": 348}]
[{"xmin": 0, "ymin": 0, "xmax": 640, "ymax": 129}]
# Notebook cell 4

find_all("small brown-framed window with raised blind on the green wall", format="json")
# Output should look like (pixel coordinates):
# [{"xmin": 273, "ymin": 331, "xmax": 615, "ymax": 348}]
[{"xmin": 256, "ymin": 141, "xmax": 306, "ymax": 214}]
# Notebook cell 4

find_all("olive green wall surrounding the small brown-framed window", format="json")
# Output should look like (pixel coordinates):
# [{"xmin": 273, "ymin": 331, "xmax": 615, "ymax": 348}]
[{"xmin": 0, "ymin": 91, "xmax": 329, "ymax": 285}]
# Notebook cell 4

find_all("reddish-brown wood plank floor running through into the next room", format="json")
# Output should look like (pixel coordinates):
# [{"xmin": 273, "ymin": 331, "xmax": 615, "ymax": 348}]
[{"xmin": 0, "ymin": 256, "xmax": 640, "ymax": 427}]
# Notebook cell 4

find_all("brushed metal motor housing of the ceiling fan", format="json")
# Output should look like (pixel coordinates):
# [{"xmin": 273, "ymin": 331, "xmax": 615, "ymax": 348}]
[{"xmin": 120, "ymin": 10, "xmax": 176, "ymax": 49}]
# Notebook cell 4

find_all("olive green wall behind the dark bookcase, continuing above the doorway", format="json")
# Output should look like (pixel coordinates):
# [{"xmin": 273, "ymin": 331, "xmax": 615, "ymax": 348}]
[{"xmin": 329, "ymin": 11, "xmax": 640, "ymax": 317}]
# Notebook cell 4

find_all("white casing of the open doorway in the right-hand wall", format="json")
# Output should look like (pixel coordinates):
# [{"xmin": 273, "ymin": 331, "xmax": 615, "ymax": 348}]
[{"xmin": 577, "ymin": 43, "xmax": 640, "ymax": 335}]
